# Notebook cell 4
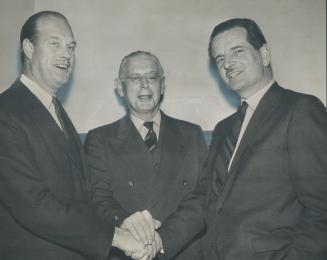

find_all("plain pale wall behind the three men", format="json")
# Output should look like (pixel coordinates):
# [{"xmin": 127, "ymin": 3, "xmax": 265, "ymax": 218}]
[{"xmin": 0, "ymin": 0, "xmax": 326, "ymax": 132}]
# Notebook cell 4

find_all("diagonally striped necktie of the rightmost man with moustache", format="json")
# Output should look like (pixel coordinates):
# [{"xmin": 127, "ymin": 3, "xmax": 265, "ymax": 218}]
[{"xmin": 219, "ymin": 101, "xmax": 248, "ymax": 182}]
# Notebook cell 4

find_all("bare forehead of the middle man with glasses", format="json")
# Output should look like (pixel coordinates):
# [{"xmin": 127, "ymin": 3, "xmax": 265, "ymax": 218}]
[{"xmin": 124, "ymin": 54, "xmax": 159, "ymax": 73}]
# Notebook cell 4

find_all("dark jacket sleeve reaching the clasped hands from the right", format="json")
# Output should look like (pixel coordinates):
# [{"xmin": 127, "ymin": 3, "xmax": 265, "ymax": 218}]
[{"xmin": 159, "ymin": 128, "xmax": 207, "ymax": 259}]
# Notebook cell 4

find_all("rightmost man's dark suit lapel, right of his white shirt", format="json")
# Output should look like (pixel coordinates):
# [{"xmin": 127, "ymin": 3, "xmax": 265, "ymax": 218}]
[{"xmin": 217, "ymin": 83, "xmax": 282, "ymax": 209}]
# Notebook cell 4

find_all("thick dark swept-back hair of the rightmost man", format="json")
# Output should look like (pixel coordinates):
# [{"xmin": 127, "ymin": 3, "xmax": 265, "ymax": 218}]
[{"xmin": 209, "ymin": 18, "xmax": 267, "ymax": 56}]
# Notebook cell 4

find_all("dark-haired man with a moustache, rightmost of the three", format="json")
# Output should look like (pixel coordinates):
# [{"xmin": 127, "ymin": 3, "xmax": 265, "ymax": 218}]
[{"xmin": 204, "ymin": 19, "xmax": 327, "ymax": 260}]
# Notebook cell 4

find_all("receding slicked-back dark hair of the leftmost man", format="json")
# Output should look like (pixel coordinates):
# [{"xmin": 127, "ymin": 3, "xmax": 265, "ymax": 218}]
[{"xmin": 20, "ymin": 11, "xmax": 68, "ymax": 63}]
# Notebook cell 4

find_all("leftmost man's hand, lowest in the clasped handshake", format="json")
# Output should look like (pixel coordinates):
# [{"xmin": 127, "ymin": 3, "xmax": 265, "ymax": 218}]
[{"xmin": 112, "ymin": 227, "xmax": 151, "ymax": 259}]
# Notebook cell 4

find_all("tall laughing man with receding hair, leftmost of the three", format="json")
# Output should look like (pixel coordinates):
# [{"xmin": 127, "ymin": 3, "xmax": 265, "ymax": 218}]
[{"xmin": 0, "ymin": 11, "xmax": 147, "ymax": 260}]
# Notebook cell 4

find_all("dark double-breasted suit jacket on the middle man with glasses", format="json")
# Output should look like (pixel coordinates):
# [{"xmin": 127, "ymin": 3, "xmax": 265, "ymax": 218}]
[{"xmin": 85, "ymin": 113, "xmax": 207, "ymax": 260}]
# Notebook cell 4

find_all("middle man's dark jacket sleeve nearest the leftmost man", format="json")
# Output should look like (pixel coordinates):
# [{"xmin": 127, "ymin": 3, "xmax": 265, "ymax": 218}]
[{"xmin": 85, "ymin": 131, "xmax": 129, "ymax": 226}]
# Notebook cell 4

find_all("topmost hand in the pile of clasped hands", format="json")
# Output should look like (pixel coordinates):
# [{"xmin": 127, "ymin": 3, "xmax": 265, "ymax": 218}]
[{"xmin": 120, "ymin": 210, "xmax": 161, "ymax": 245}]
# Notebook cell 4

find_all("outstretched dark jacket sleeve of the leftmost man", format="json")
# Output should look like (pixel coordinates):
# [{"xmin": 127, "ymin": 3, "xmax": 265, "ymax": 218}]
[{"xmin": 0, "ymin": 110, "xmax": 114, "ymax": 259}]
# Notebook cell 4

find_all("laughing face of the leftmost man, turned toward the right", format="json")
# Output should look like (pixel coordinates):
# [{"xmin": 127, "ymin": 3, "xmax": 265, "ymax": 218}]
[{"xmin": 23, "ymin": 17, "xmax": 76, "ymax": 94}]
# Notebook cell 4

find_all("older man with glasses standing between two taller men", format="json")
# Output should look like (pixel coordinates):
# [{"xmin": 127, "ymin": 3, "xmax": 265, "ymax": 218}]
[{"xmin": 85, "ymin": 51, "xmax": 207, "ymax": 260}]
